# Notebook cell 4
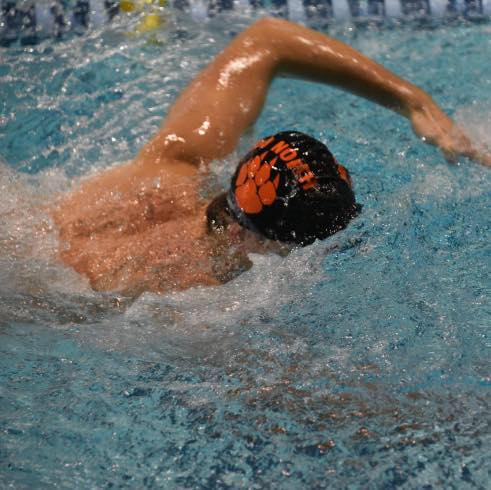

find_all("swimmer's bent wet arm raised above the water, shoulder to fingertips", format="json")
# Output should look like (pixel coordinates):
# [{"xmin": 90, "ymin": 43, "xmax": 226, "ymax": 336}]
[{"xmin": 138, "ymin": 18, "xmax": 491, "ymax": 165}]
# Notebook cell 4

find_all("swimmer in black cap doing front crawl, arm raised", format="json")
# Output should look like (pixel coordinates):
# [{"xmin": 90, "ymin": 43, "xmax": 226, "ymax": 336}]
[{"xmin": 52, "ymin": 18, "xmax": 491, "ymax": 295}]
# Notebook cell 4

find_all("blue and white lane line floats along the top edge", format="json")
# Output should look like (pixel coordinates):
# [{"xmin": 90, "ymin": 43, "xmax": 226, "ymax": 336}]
[{"xmin": 0, "ymin": 0, "xmax": 491, "ymax": 46}]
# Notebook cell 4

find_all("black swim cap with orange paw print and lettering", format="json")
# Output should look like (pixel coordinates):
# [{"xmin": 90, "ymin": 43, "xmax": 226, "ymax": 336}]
[{"xmin": 228, "ymin": 131, "xmax": 359, "ymax": 245}]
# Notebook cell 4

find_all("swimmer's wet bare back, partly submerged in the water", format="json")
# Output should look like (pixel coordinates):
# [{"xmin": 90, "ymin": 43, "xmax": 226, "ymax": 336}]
[{"xmin": 52, "ymin": 157, "xmax": 217, "ymax": 294}]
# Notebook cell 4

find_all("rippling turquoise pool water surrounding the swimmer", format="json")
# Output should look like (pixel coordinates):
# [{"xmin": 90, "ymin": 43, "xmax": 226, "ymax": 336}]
[{"xmin": 0, "ymin": 14, "xmax": 491, "ymax": 489}]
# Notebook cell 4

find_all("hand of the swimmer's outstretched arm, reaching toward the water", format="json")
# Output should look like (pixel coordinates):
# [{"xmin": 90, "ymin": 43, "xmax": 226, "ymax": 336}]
[{"xmin": 409, "ymin": 94, "xmax": 491, "ymax": 167}]
